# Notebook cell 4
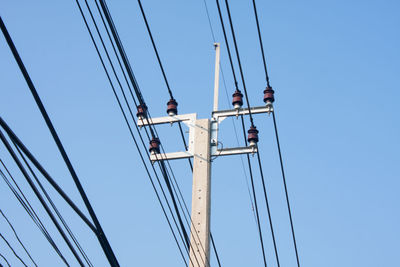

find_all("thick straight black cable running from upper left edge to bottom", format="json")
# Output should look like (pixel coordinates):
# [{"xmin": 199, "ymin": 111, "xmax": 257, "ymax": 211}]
[{"xmin": 0, "ymin": 17, "xmax": 119, "ymax": 267}]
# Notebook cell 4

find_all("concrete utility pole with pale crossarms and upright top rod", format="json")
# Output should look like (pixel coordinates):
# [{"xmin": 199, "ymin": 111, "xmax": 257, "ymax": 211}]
[{"xmin": 138, "ymin": 43, "xmax": 272, "ymax": 267}]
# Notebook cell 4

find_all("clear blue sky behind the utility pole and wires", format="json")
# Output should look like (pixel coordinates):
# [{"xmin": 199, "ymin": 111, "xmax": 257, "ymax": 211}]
[{"xmin": 0, "ymin": 0, "xmax": 400, "ymax": 267}]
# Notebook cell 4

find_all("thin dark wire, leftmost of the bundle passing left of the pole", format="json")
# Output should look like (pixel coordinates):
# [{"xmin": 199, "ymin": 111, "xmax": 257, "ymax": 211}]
[{"xmin": 77, "ymin": 1, "xmax": 191, "ymax": 266}]
